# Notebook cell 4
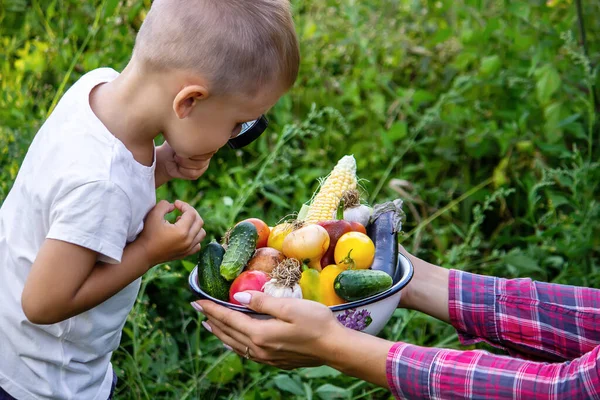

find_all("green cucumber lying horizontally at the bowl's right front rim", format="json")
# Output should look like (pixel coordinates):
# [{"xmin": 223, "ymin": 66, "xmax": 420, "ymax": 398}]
[{"xmin": 333, "ymin": 269, "xmax": 392, "ymax": 301}]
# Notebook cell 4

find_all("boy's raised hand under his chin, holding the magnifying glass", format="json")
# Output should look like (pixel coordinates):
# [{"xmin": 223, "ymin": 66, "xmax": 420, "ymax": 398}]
[{"xmin": 156, "ymin": 142, "xmax": 215, "ymax": 187}]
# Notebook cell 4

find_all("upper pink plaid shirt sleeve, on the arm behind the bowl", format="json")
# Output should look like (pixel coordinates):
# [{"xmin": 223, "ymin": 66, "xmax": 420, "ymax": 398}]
[{"xmin": 448, "ymin": 270, "xmax": 600, "ymax": 361}]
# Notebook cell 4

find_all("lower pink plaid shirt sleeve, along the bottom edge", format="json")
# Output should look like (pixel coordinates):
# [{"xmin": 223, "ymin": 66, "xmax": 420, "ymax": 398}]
[{"xmin": 387, "ymin": 343, "xmax": 600, "ymax": 400}]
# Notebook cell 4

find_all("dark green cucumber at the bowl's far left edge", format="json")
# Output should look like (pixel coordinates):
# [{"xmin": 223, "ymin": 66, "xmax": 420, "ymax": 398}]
[{"xmin": 198, "ymin": 241, "xmax": 231, "ymax": 301}]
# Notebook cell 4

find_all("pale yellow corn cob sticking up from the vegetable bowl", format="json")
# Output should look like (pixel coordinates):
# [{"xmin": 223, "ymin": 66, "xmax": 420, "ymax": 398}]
[{"xmin": 304, "ymin": 156, "xmax": 357, "ymax": 224}]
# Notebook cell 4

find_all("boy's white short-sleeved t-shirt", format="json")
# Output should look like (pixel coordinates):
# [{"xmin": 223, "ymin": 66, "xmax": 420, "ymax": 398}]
[{"xmin": 0, "ymin": 68, "xmax": 156, "ymax": 400}]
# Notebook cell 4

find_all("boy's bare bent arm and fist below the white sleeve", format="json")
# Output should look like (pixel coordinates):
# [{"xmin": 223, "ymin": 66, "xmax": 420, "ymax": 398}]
[{"xmin": 21, "ymin": 201, "xmax": 206, "ymax": 324}]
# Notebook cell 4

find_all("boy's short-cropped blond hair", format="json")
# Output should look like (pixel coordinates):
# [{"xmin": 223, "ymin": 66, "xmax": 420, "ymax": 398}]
[{"xmin": 133, "ymin": 0, "xmax": 300, "ymax": 94}]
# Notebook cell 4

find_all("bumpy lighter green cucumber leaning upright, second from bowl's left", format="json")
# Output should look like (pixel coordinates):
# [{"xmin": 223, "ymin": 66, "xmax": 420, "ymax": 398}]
[{"xmin": 221, "ymin": 221, "xmax": 258, "ymax": 281}]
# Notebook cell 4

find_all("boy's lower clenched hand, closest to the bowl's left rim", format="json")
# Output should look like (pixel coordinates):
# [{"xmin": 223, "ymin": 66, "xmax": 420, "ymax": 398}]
[{"xmin": 137, "ymin": 200, "xmax": 206, "ymax": 266}]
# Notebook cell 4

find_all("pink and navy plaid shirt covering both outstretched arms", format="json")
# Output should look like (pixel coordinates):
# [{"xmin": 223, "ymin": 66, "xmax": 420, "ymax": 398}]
[{"xmin": 387, "ymin": 270, "xmax": 600, "ymax": 400}]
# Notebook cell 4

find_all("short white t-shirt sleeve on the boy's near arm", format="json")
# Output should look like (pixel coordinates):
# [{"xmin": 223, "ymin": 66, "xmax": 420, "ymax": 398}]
[{"xmin": 46, "ymin": 181, "xmax": 132, "ymax": 263}]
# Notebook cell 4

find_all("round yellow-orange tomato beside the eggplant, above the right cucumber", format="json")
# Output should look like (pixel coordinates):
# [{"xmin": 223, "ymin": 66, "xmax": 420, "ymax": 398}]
[{"xmin": 333, "ymin": 232, "xmax": 375, "ymax": 269}]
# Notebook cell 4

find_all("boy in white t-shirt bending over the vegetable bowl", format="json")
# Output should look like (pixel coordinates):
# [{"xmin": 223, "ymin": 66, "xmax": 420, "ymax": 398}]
[{"xmin": 0, "ymin": 0, "xmax": 299, "ymax": 400}]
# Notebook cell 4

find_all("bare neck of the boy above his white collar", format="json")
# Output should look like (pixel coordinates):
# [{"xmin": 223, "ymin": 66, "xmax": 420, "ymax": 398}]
[{"xmin": 90, "ymin": 62, "xmax": 164, "ymax": 166}]
